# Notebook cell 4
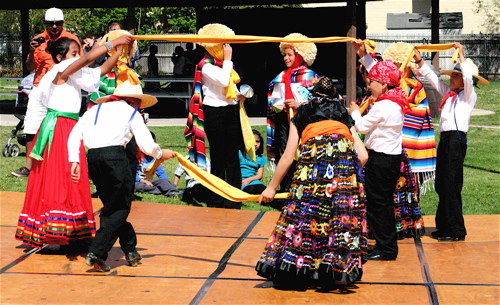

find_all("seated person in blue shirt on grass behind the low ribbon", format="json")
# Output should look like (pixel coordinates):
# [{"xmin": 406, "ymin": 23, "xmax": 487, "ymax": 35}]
[{"xmin": 238, "ymin": 129, "xmax": 267, "ymax": 194}]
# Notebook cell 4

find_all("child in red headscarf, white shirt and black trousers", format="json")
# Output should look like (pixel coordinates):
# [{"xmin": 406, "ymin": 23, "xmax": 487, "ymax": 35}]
[{"xmin": 349, "ymin": 60, "xmax": 407, "ymax": 260}]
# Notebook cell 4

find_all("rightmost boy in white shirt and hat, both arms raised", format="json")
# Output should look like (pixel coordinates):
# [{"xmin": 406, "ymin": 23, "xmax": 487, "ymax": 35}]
[{"xmin": 414, "ymin": 42, "xmax": 489, "ymax": 241}]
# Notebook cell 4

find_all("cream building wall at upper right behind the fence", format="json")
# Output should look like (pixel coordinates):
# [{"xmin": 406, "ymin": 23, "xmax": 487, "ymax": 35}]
[{"xmin": 304, "ymin": 0, "xmax": 494, "ymax": 34}]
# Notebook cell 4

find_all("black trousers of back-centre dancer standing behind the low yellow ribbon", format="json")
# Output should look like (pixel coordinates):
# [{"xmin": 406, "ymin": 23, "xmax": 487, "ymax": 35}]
[{"xmin": 203, "ymin": 105, "xmax": 244, "ymax": 208}]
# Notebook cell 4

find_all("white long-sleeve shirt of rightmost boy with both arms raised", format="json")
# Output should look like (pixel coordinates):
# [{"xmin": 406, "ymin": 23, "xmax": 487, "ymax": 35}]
[{"xmin": 419, "ymin": 62, "xmax": 477, "ymax": 132}]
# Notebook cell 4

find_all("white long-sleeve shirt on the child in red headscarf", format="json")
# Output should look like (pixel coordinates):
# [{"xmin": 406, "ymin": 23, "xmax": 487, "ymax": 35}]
[{"xmin": 351, "ymin": 100, "xmax": 404, "ymax": 155}]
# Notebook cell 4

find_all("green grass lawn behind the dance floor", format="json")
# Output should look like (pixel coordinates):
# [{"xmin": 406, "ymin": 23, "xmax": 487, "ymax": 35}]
[{"xmin": 0, "ymin": 82, "xmax": 500, "ymax": 215}]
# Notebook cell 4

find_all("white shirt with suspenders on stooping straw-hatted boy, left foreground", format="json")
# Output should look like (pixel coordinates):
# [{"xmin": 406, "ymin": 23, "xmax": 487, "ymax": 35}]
[{"xmin": 68, "ymin": 101, "xmax": 162, "ymax": 162}]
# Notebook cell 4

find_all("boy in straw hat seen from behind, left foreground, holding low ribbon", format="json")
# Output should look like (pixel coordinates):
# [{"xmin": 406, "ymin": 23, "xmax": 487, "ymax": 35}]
[{"xmin": 68, "ymin": 81, "xmax": 175, "ymax": 272}]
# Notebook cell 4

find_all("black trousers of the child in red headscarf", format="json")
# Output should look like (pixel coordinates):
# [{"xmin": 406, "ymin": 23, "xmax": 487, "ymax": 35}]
[{"xmin": 365, "ymin": 150, "xmax": 401, "ymax": 257}]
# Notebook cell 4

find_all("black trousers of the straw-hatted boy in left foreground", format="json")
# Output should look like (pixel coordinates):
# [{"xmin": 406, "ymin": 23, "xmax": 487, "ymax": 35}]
[{"xmin": 88, "ymin": 146, "xmax": 137, "ymax": 260}]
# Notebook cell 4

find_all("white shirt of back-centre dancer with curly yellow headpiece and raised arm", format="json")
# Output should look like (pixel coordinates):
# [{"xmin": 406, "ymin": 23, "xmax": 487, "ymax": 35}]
[{"xmin": 201, "ymin": 60, "xmax": 238, "ymax": 107}]
